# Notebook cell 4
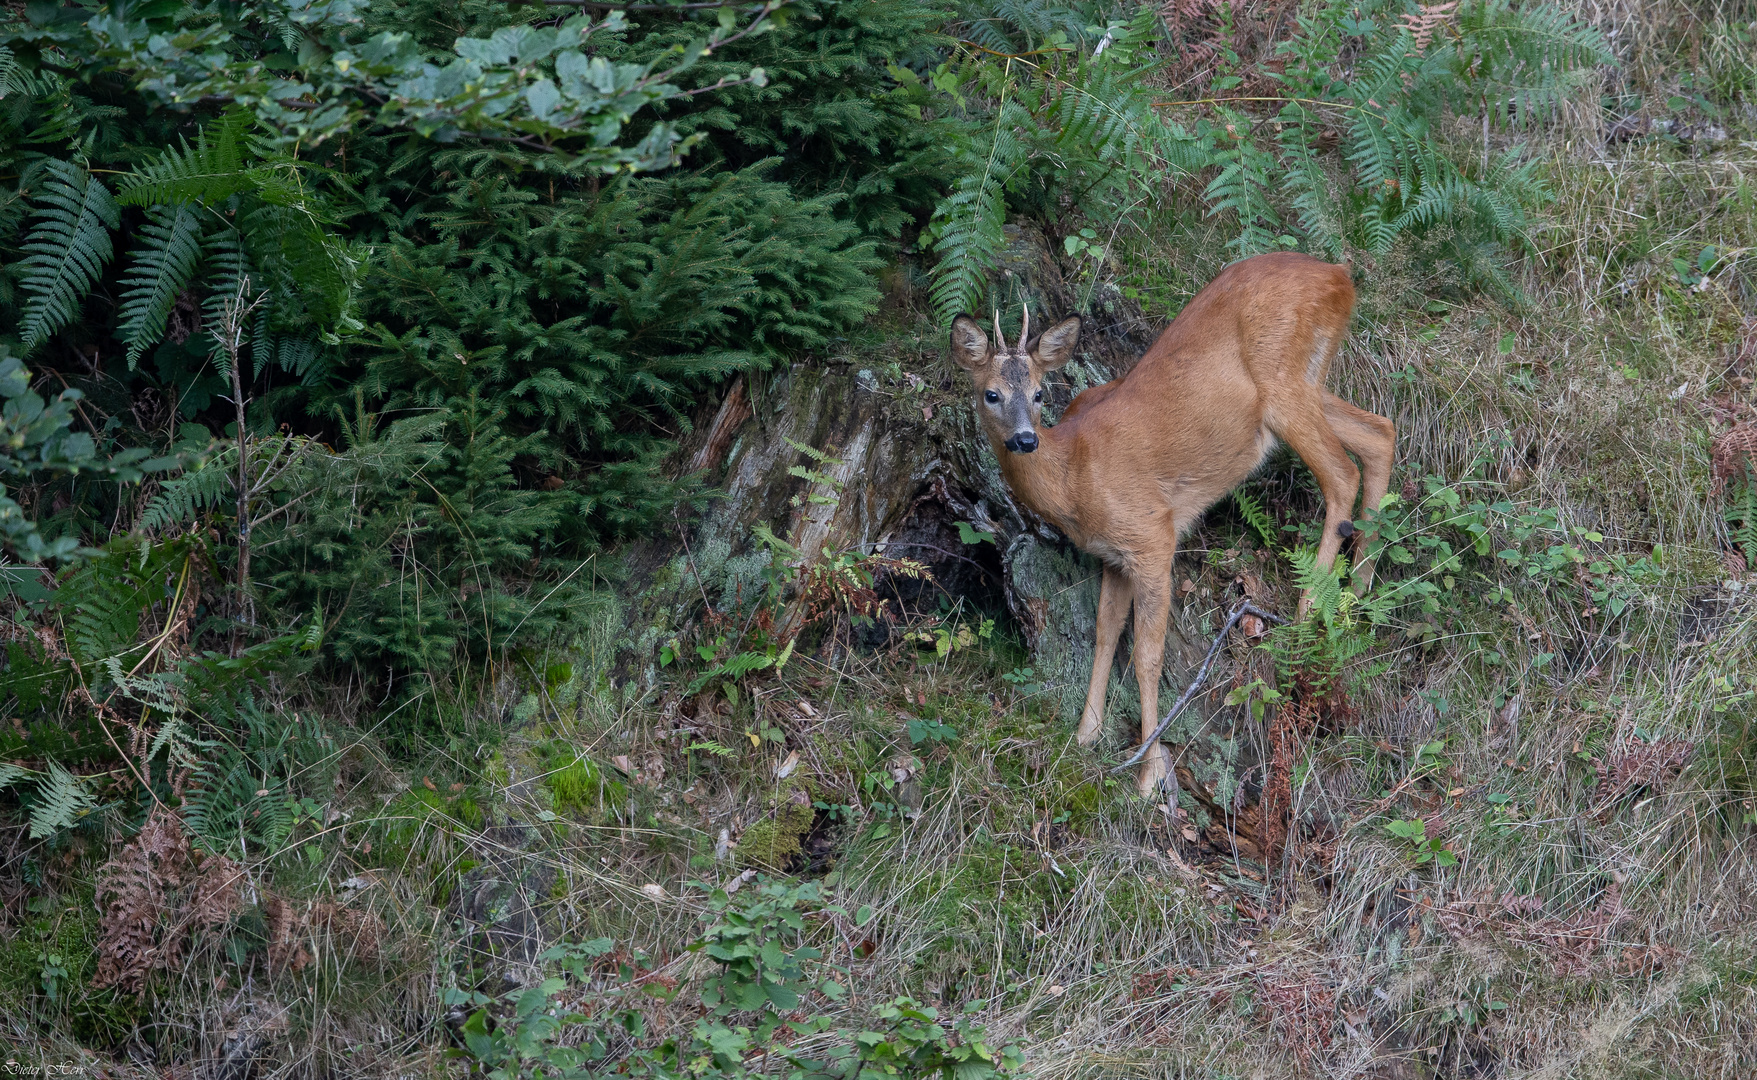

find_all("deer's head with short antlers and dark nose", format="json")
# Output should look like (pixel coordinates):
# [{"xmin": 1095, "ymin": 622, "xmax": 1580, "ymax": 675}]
[{"xmin": 952, "ymin": 311, "xmax": 1081, "ymax": 453}]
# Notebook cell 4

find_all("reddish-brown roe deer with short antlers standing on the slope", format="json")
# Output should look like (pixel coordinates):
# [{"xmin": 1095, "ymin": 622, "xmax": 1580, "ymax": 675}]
[{"xmin": 952, "ymin": 253, "xmax": 1397, "ymax": 796}]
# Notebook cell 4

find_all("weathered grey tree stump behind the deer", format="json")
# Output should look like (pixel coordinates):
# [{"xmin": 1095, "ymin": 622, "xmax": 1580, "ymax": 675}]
[{"xmin": 624, "ymin": 228, "xmax": 1258, "ymax": 772}]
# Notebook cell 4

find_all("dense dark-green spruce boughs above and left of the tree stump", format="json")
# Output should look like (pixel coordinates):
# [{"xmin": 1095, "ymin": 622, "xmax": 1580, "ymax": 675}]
[{"xmin": 353, "ymin": 151, "xmax": 879, "ymax": 536}]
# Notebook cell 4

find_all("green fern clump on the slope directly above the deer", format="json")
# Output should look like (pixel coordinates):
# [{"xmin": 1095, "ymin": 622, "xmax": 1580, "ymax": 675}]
[{"xmin": 928, "ymin": 0, "xmax": 1611, "ymax": 316}]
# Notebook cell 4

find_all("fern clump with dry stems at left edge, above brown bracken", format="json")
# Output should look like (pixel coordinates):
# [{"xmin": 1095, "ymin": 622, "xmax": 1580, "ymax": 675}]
[{"xmin": 0, "ymin": 530, "xmax": 322, "ymax": 850}]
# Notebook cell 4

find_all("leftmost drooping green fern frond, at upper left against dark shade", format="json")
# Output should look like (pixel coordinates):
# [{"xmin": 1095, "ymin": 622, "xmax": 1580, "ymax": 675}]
[{"xmin": 19, "ymin": 162, "xmax": 121, "ymax": 353}]
